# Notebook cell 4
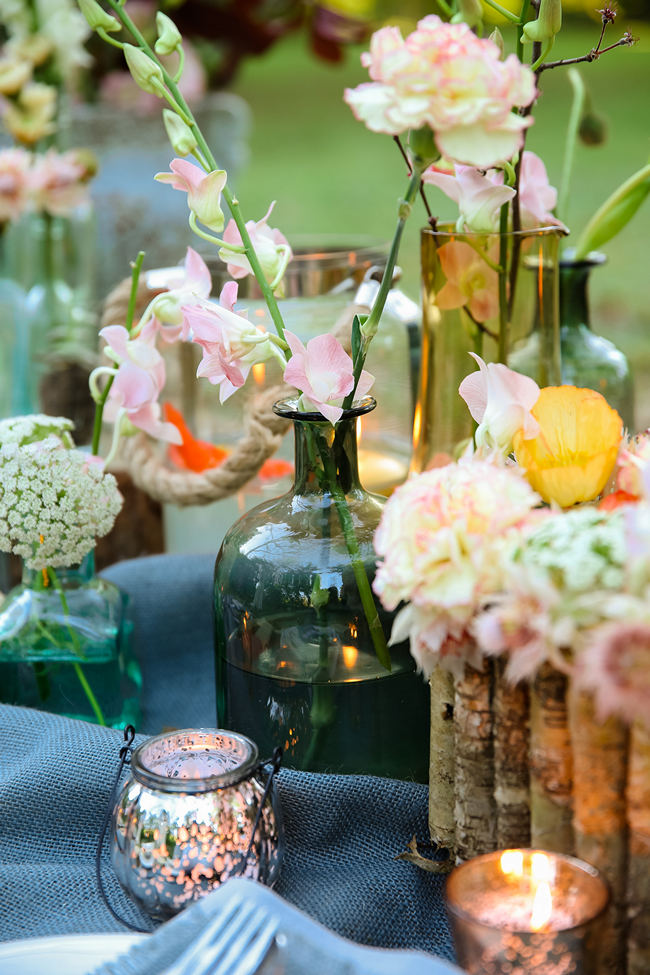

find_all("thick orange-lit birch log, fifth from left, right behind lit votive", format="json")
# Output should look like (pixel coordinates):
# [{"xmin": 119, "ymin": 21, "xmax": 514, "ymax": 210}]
[{"xmin": 569, "ymin": 688, "xmax": 628, "ymax": 975}]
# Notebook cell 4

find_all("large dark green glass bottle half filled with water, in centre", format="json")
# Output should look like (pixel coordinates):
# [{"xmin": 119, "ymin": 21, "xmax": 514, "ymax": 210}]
[{"xmin": 214, "ymin": 398, "xmax": 429, "ymax": 782}]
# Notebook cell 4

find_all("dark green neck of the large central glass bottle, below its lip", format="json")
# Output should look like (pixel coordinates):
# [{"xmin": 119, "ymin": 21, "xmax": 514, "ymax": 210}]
[{"xmin": 293, "ymin": 416, "xmax": 361, "ymax": 494}]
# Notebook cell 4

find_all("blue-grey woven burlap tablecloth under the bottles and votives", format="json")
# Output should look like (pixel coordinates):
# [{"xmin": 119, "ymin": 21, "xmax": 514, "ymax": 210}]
[{"xmin": 0, "ymin": 556, "xmax": 453, "ymax": 960}]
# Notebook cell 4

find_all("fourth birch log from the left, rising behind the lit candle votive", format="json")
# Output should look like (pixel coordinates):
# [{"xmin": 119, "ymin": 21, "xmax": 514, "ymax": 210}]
[{"xmin": 530, "ymin": 664, "xmax": 574, "ymax": 853}]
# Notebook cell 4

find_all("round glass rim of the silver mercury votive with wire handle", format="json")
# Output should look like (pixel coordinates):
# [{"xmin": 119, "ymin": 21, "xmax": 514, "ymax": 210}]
[{"xmin": 131, "ymin": 728, "xmax": 259, "ymax": 793}]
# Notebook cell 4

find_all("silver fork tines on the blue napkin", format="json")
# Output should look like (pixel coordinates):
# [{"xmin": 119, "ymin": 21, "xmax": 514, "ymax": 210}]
[{"xmin": 164, "ymin": 901, "xmax": 278, "ymax": 975}]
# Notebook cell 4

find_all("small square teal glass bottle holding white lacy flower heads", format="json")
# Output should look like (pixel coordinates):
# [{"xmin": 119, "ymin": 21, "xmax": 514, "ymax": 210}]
[{"xmin": 0, "ymin": 552, "xmax": 142, "ymax": 728}]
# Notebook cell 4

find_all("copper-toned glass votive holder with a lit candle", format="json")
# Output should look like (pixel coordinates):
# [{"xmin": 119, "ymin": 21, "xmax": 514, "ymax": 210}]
[{"xmin": 446, "ymin": 850, "xmax": 609, "ymax": 975}]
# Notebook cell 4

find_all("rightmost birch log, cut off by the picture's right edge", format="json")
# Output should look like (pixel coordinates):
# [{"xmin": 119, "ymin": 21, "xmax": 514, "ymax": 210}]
[{"xmin": 627, "ymin": 720, "xmax": 650, "ymax": 975}]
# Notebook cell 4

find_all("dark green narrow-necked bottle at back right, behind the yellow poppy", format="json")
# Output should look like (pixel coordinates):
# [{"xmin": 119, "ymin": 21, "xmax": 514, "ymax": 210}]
[{"xmin": 560, "ymin": 252, "xmax": 635, "ymax": 432}]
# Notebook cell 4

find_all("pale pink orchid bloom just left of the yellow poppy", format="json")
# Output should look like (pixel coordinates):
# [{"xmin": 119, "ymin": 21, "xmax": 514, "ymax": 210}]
[{"xmin": 458, "ymin": 352, "xmax": 539, "ymax": 453}]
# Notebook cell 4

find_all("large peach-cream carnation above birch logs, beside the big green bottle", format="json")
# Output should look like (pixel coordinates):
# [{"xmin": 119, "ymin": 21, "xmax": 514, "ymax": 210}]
[{"xmin": 373, "ymin": 460, "xmax": 539, "ymax": 675}]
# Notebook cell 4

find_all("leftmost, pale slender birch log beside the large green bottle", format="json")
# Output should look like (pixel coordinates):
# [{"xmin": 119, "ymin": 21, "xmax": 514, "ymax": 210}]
[{"xmin": 429, "ymin": 667, "xmax": 456, "ymax": 850}]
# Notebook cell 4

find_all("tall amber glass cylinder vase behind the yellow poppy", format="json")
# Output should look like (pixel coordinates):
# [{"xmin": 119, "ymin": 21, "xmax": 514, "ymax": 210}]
[{"xmin": 412, "ymin": 227, "xmax": 563, "ymax": 471}]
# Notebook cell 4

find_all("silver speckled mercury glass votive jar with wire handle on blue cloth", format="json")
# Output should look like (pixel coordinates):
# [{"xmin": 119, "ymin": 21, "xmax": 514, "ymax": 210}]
[{"xmin": 111, "ymin": 728, "xmax": 283, "ymax": 918}]
